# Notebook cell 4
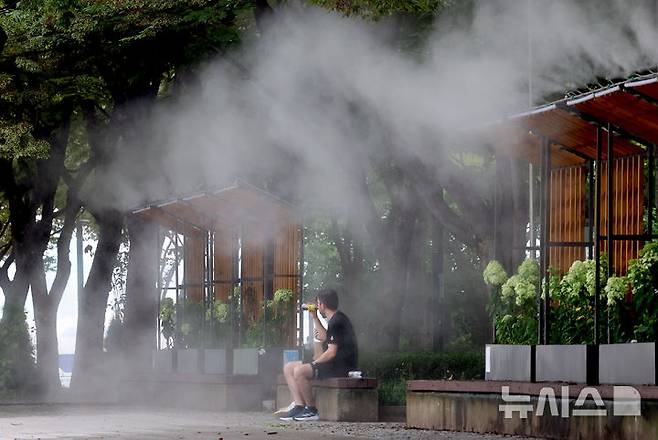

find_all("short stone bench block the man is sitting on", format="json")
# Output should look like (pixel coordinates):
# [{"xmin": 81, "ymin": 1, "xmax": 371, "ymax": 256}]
[{"xmin": 276, "ymin": 374, "xmax": 379, "ymax": 422}]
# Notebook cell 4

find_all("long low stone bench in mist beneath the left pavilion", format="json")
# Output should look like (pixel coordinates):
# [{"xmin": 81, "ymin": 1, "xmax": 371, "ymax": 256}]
[{"xmin": 119, "ymin": 373, "xmax": 262, "ymax": 411}]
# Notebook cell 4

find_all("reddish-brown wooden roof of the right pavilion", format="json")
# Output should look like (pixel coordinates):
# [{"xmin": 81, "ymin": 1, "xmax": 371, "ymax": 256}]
[{"xmin": 493, "ymin": 74, "xmax": 658, "ymax": 167}]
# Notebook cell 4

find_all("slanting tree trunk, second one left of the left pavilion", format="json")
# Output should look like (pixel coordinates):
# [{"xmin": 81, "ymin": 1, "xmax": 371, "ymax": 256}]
[{"xmin": 71, "ymin": 211, "xmax": 122, "ymax": 397}]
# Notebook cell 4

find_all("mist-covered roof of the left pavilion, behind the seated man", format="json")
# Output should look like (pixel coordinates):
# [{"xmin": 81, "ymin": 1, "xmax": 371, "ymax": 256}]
[{"xmin": 132, "ymin": 181, "xmax": 298, "ymax": 234}]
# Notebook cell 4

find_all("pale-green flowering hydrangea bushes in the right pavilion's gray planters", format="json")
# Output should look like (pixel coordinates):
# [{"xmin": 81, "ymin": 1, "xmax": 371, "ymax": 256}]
[{"xmin": 484, "ymin": 242, "xmax": 658, "ymax": 344}]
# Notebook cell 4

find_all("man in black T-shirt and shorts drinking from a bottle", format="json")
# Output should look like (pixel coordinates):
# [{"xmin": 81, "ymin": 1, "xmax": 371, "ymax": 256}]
[{"xmin": 280, "ymin": 289, "xmax": 358, "ymax": 421}]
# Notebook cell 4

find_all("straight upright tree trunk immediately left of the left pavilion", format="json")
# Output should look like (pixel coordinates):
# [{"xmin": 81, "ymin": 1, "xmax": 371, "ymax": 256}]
[{"xmin": 122, "ymin": 217, "xmax": 159, "ymax": 372}]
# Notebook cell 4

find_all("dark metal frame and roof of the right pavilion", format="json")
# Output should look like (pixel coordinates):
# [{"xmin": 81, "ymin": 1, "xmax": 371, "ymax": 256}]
[{"xmin": 494, "ymin": 74, "xmax": 658, "ymax": 345}]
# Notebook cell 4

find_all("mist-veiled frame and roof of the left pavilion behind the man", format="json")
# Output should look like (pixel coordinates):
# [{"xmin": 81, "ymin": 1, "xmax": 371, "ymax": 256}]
[{"xmin": 132, "ymin": 182, "xmax": 304, "ymax": 358}]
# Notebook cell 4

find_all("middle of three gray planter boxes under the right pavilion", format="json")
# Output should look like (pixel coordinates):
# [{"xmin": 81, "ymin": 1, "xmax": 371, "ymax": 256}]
[{"xmin": 535, "ymin": 345, "xmax": 598, "ymax": 385}]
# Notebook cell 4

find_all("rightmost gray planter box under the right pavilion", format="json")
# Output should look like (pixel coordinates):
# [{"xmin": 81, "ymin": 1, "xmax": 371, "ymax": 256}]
[{"xmin": 599, "ymin": 342, "xmax": 656, "ymax": 385}]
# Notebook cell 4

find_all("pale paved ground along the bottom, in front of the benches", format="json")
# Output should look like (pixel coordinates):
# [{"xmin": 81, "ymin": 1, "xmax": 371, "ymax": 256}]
[{"xmin": 0, "ymin": 405, "xmax": 532, "ymax": 440}]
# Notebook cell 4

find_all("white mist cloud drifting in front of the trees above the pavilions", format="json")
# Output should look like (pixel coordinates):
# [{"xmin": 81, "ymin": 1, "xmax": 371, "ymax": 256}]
[{"xmin": 95, "ymin": 0, "xmax": 658, "ymax": 223}]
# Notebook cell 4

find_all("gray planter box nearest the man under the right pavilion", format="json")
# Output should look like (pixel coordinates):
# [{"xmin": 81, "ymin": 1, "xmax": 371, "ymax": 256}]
[{"xmin": 484, "ymin": 344, "xmax": 535, "ymax": 382}]
